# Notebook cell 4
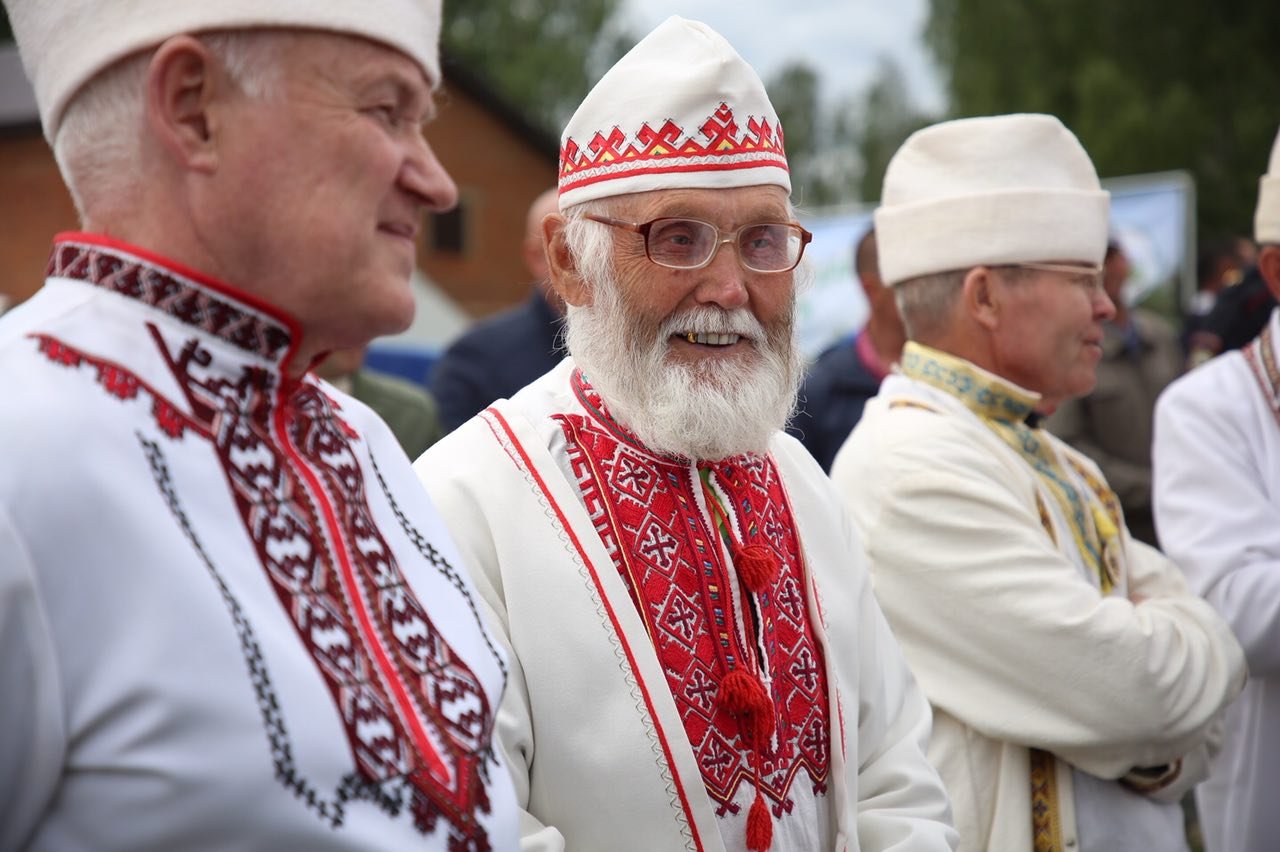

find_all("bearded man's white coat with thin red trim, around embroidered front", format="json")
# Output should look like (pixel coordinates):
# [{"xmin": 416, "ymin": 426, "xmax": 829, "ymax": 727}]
[{"xmin": 415, "ymin": 358, "xmax": 956, "ymax": 852}]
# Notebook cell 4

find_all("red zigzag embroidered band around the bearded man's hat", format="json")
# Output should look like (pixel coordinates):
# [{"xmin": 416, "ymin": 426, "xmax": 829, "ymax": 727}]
[{"xmin": 559, "ymin": 104, "xmax": 787, "ymax": 193}]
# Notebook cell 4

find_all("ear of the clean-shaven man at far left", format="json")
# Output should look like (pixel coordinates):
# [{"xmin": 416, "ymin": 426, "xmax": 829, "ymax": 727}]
[{"xmin": 146, "ymin": 36, "xmax": 225, "ymax": 171}]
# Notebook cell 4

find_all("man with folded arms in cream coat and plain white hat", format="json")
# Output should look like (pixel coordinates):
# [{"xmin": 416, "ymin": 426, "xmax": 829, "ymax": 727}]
[{"xmin": 832, "ymin": 115, "xmax": 1244, "ymax": 852}]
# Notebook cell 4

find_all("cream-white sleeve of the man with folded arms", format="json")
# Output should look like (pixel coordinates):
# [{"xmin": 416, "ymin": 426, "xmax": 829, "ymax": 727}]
[{"xmin": 833, "ymin": 424, "xmax": 1244, "ymax": 778}]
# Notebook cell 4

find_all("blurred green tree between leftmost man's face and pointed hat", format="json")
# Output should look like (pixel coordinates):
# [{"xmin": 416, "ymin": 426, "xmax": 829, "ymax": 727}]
[{"xmin": 442, "ymin": 0, "xmax": 636, "ymax": 136}]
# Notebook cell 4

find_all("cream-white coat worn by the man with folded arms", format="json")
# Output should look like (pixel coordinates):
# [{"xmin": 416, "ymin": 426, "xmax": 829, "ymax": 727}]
[{"xmin": 832, "ymin": 347, "xmax": 1244, "ymax": 852}]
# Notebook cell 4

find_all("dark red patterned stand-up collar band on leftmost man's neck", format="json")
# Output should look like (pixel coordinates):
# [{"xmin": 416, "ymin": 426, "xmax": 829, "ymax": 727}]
[{"xmin": 47, "ymin": 239, "xmax": 289, "ymax": 359}]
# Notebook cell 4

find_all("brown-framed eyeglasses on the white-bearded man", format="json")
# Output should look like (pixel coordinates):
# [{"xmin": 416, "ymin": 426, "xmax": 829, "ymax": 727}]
[{"xmin": 586, "ymin": 214, "xmax": 813, "ymax": 272}]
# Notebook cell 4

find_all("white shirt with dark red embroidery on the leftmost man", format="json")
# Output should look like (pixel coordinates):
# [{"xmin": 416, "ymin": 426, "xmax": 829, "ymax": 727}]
[{"xmin": 0, "ymin": 234, "xmax": 517, "ymax": 852}]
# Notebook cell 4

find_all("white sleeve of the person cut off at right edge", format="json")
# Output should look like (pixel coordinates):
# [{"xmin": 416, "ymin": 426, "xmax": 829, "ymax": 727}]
[{"xmin": 1152, "ymin": 370, "xmax": 1280, "ymax": 678}]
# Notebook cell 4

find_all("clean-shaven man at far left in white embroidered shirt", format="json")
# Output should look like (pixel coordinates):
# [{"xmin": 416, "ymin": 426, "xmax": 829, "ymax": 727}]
[{"xmin": 0, "ymin": 0, "xmax": 518, "ymax": 852}]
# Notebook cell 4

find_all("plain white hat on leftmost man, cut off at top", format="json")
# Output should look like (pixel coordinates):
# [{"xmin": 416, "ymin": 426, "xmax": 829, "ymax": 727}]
[{"xmin": 5, "ymin": 0, "xmax": 442, "ymax": 142}]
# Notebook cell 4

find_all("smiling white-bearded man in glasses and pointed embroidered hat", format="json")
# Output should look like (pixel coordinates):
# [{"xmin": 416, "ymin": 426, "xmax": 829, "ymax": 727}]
[{"xmin": 416, "ymin": 18, "xmax": 957, "ymax": 852}]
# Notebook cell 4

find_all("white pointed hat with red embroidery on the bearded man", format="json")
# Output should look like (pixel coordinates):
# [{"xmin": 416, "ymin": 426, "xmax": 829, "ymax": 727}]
[{"xmin": 559, "ymin": 15, "xmax": 791, "ymax": 210}]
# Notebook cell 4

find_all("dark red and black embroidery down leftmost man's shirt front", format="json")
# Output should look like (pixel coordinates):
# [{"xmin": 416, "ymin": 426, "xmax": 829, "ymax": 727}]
[{"xmin": 35, "ymin": 239, "xmax": 506, "ymax": 851}]
